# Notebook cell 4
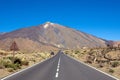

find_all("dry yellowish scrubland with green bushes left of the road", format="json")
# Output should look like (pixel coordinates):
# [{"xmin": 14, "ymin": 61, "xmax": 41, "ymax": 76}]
[{"xmin": 0, "ymin": 50, "xmax": 51, "ymax": 77}]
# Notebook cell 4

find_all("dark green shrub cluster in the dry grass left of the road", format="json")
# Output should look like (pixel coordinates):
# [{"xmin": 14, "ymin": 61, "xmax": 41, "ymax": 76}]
[{"xmin": 0, "ymin": 56, "xmax": 29, "ymax": 72}]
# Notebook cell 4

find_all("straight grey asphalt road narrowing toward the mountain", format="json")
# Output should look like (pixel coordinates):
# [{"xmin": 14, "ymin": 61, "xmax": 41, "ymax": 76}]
[{"xmin": 1, "ymin": 52, "xmax": 116, "ymax": 80}]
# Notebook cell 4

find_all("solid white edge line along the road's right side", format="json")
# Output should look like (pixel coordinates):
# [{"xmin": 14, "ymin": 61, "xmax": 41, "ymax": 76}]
[{"xmin": 67, "ymin": 55, "xmax": 120, "ymax": 80}]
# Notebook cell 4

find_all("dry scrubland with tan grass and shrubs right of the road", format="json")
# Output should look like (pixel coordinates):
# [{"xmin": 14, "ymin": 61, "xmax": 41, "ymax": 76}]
[{"xmin": 65, "ymin": 47, "xmax": 120, "ymax": 78}]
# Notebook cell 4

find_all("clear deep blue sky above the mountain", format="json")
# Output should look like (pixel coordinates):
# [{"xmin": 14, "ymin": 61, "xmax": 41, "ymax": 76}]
[{"xmin": 0, "ymin": 0, "xmax": 120, "ymax": 41}]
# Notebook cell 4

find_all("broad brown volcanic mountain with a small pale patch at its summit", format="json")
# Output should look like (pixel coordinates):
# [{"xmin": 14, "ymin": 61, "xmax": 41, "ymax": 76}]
[{"xmin": 0, "ymin": 22, "xmax": 107, "ymax": 50}]
